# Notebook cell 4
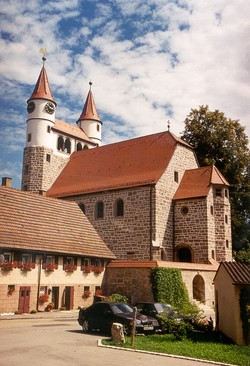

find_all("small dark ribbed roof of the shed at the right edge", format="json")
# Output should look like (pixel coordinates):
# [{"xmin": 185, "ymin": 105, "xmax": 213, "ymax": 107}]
[{"xmin": 215, "ymin": 262, "xmax": 250, "ymax": 285}]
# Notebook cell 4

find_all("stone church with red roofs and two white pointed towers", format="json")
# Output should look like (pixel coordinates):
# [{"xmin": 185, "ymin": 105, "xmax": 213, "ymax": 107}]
[{"xmin": 0, "ymin": 58, "xmax": 232, "ymax": 314}]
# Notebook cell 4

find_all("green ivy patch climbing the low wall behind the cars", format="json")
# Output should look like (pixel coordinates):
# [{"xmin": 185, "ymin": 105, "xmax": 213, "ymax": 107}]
[{"xmin": 151, "ymin": 267, "xmax": 189, "ymax": 309}]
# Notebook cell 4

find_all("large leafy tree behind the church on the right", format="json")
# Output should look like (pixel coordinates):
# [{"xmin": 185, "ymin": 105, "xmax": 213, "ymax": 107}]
[{"xmin": 181, "ymin": 105, "xmax": 250, "ymax": 249}]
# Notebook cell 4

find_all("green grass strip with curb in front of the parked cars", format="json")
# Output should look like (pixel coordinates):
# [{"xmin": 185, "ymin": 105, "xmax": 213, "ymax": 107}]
[{"xmin": 102, "ymin": 332, "xmax": 250, "ymax": 366}]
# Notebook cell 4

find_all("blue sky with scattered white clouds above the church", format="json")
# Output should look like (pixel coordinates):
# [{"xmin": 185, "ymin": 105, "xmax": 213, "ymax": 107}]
[{"xmin": 0, "ymin": 0, "xmax": 250, "ymax": 188}]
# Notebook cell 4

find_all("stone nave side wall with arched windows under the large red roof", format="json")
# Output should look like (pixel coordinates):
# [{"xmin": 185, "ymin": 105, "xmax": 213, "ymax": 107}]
[{"xmin": 71, "ymin": 186, "xmax": 152, "ymax": 260}]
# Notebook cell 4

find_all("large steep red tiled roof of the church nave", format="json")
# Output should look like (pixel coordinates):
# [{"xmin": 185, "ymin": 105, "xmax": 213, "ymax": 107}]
[{"xmin": 47, "ymin": 132, "xmax": 190, "ymax": 197}]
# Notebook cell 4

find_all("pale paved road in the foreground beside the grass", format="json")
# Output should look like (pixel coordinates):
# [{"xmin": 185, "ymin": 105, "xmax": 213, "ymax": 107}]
[{"xmin": 0, "ymin": 314, "xmax": 223, "ymax": 366}]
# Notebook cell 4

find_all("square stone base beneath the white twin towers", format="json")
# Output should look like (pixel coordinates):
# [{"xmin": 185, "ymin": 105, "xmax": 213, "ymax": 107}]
[{"xmin": 22, "ymin": 146, "xmax": 68, "ymax": 193}]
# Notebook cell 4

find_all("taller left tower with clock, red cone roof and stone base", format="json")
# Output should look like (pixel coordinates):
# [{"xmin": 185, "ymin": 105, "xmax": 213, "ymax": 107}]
[{"xmin": 22, "ymin": 57, "xmax": 59, "ymax": 193}]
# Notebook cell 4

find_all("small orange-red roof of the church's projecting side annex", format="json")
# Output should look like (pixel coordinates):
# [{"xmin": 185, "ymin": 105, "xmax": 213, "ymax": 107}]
[{"xmin": 173, "ymin": 166, "xmax": 229, "ymax": 200}]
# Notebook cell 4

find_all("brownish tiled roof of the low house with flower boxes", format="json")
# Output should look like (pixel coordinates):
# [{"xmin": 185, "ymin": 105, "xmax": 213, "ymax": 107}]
[{"xmin": 0, "ymin": 186, "xmax": 115, "ymax": 258}]
